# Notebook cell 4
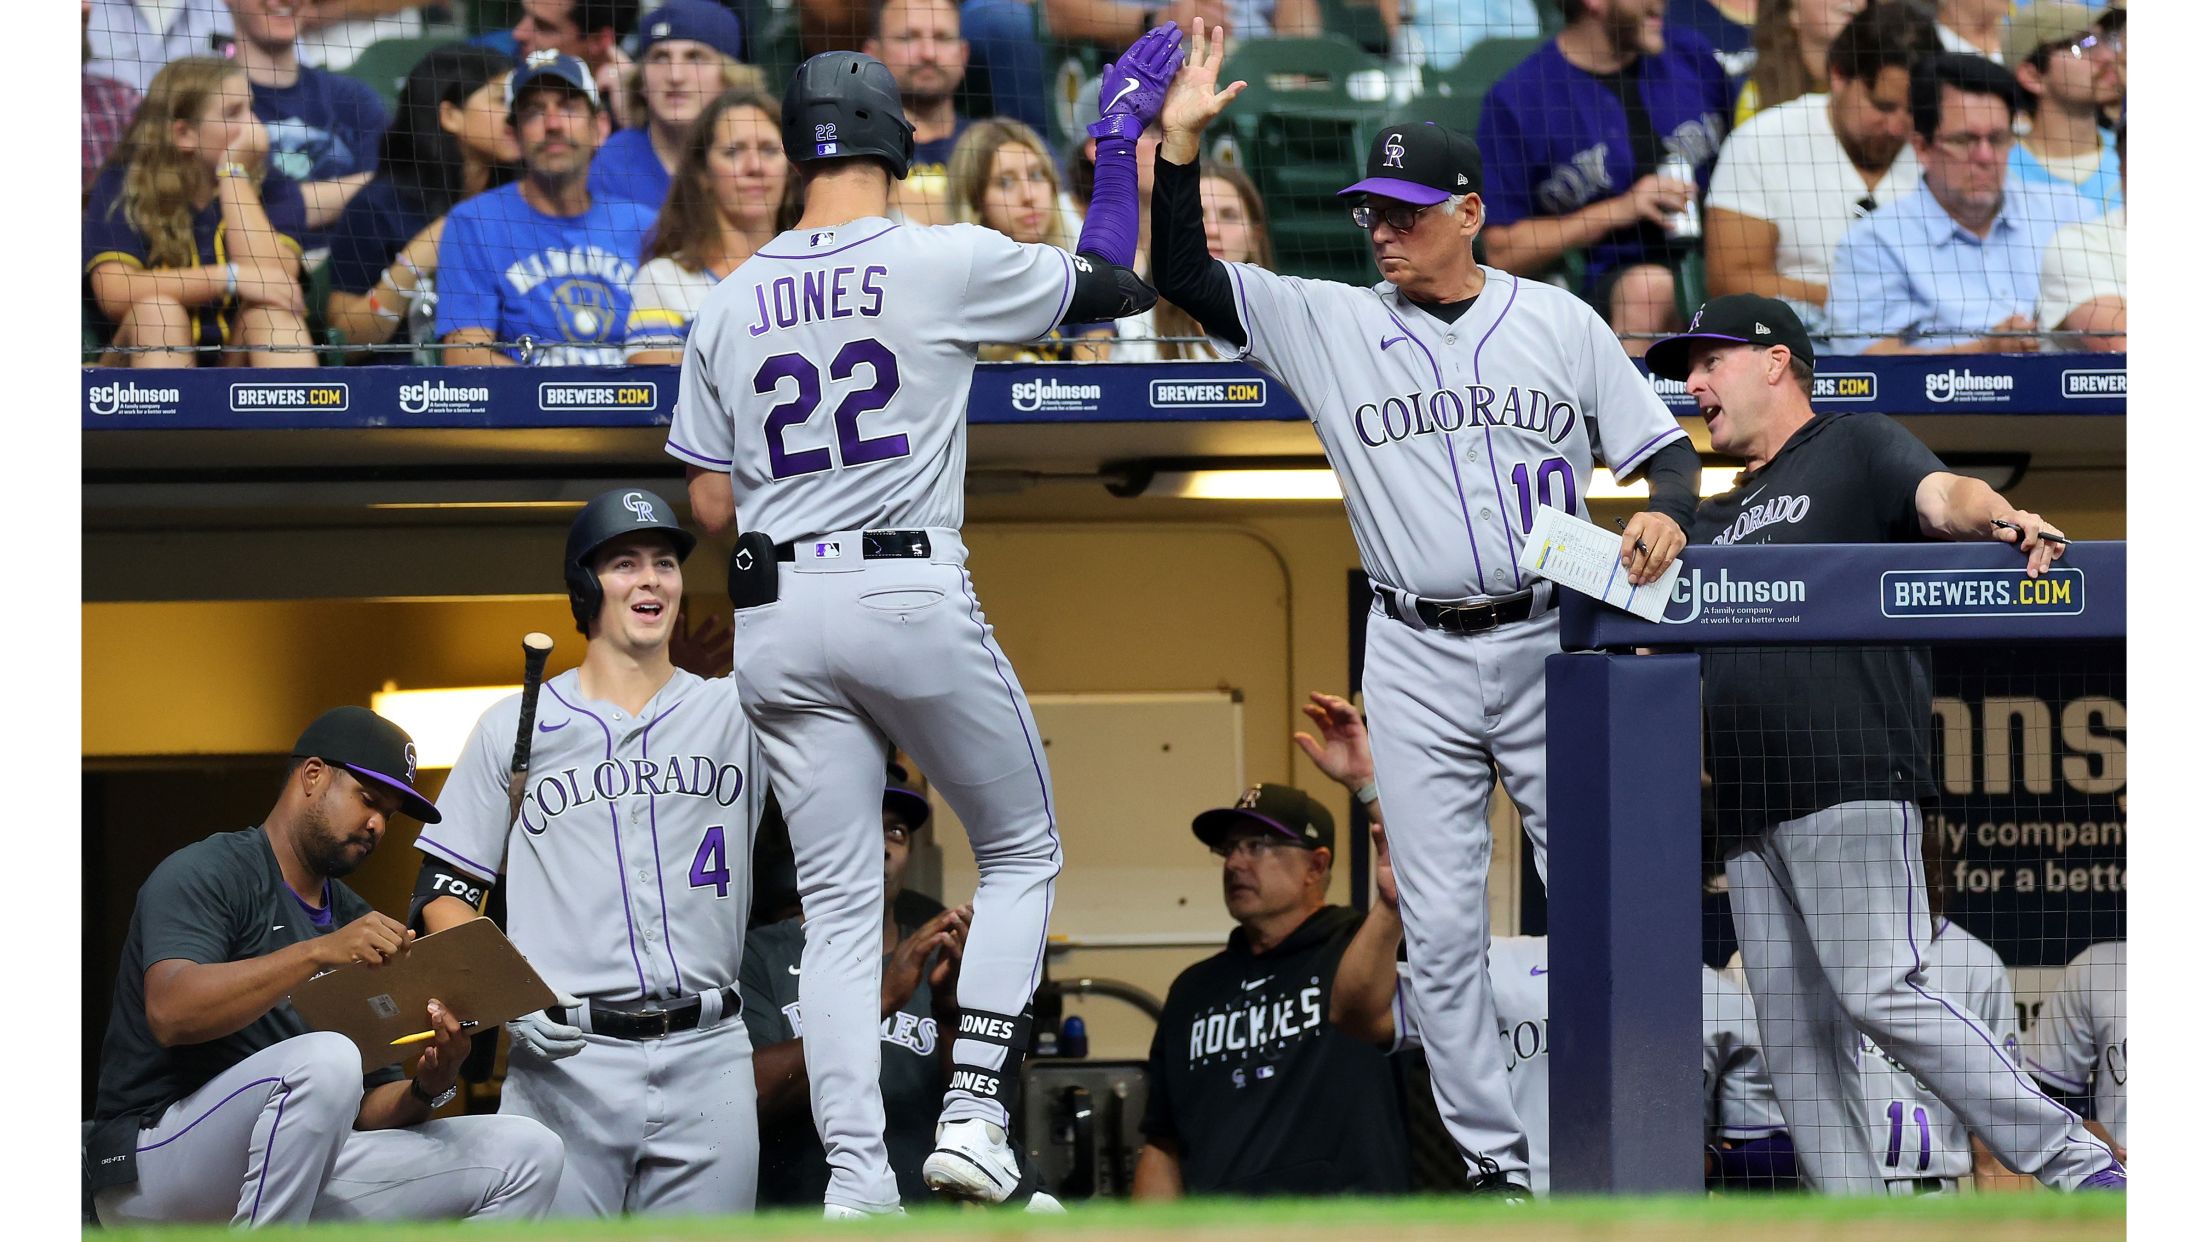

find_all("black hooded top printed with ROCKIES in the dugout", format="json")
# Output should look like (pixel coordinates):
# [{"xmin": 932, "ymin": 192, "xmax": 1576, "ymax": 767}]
[{"xmin": 1142, "ymin": 906, "xmax": 1411, "ymax": 1196}]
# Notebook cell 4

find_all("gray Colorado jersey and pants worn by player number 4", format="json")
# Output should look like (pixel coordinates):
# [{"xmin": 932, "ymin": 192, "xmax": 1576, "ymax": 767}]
[{"xmin": 415, "ymin": 670, "xmax": 766, "ymax": 1215}]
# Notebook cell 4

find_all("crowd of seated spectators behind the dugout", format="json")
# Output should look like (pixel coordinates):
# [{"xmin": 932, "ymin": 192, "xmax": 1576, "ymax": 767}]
[{"xmin": 82, "ymin": 0, "xmax": 2126, "ymax": 367}]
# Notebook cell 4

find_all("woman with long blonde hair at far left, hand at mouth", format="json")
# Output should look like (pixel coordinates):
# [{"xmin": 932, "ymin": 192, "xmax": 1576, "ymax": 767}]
[{"xmin": 84, "ymin": 55, "xmax": 316, "ymax": 367}]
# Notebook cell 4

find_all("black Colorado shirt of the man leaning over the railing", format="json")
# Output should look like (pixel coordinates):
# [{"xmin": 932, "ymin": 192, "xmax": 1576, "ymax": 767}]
[{"xmin": 1687, "ymin": 413, "xmax": 1947, "ymax": 844}]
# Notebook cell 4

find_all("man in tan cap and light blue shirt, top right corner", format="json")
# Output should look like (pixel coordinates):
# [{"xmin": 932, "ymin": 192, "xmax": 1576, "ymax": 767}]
[{"xmin": 2003, "ymin": 0, "xmax": 2124, "ymax": 214}]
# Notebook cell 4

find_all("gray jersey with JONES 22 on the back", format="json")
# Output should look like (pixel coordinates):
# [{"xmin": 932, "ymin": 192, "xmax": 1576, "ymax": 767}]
[{"xmin": 667, "ymin": 219, "xmax": 1073, "ymax": 541}]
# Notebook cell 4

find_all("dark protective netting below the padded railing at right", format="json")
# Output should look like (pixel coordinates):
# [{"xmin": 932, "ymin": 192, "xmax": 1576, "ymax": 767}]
[{"xmin": 1702, "ymin": 643, "xmax": 2129, "ymax": 1193}]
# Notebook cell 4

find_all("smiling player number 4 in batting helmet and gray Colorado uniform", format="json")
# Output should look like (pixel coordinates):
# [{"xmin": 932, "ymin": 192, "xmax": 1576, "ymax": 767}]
[{"xmin": 415, "ymin": 488, "xmax": 766, "ymax": 1215}]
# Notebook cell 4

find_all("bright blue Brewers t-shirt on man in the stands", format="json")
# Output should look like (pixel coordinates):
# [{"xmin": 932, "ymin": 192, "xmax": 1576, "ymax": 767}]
[{"xmin": 437, "ymin": 183, "xmax": 656, "ymax": 367}]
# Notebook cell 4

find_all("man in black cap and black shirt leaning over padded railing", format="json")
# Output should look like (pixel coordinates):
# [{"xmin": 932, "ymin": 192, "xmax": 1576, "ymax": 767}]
[{"xmin": 1647, "ymin": 294, "xmax": 2124, "ymax": 1193}]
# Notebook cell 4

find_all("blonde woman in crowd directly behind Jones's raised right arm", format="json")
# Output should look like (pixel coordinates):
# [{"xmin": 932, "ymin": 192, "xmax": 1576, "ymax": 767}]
[{"xmin": 943, "ymin": 117, "xmax": 1111, "ymax": 362}]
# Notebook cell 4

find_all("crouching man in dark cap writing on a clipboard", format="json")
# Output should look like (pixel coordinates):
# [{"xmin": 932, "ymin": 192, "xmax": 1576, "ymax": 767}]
[{"xmin": 84, "ymin": 707, "xmax": 561, "ymax": 1224}]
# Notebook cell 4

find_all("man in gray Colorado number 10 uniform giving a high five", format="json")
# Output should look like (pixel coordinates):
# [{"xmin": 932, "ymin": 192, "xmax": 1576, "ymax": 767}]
[{"xmin": 1150, "ymin": 27, "xmax": 1700, "ymax": 1193}]
